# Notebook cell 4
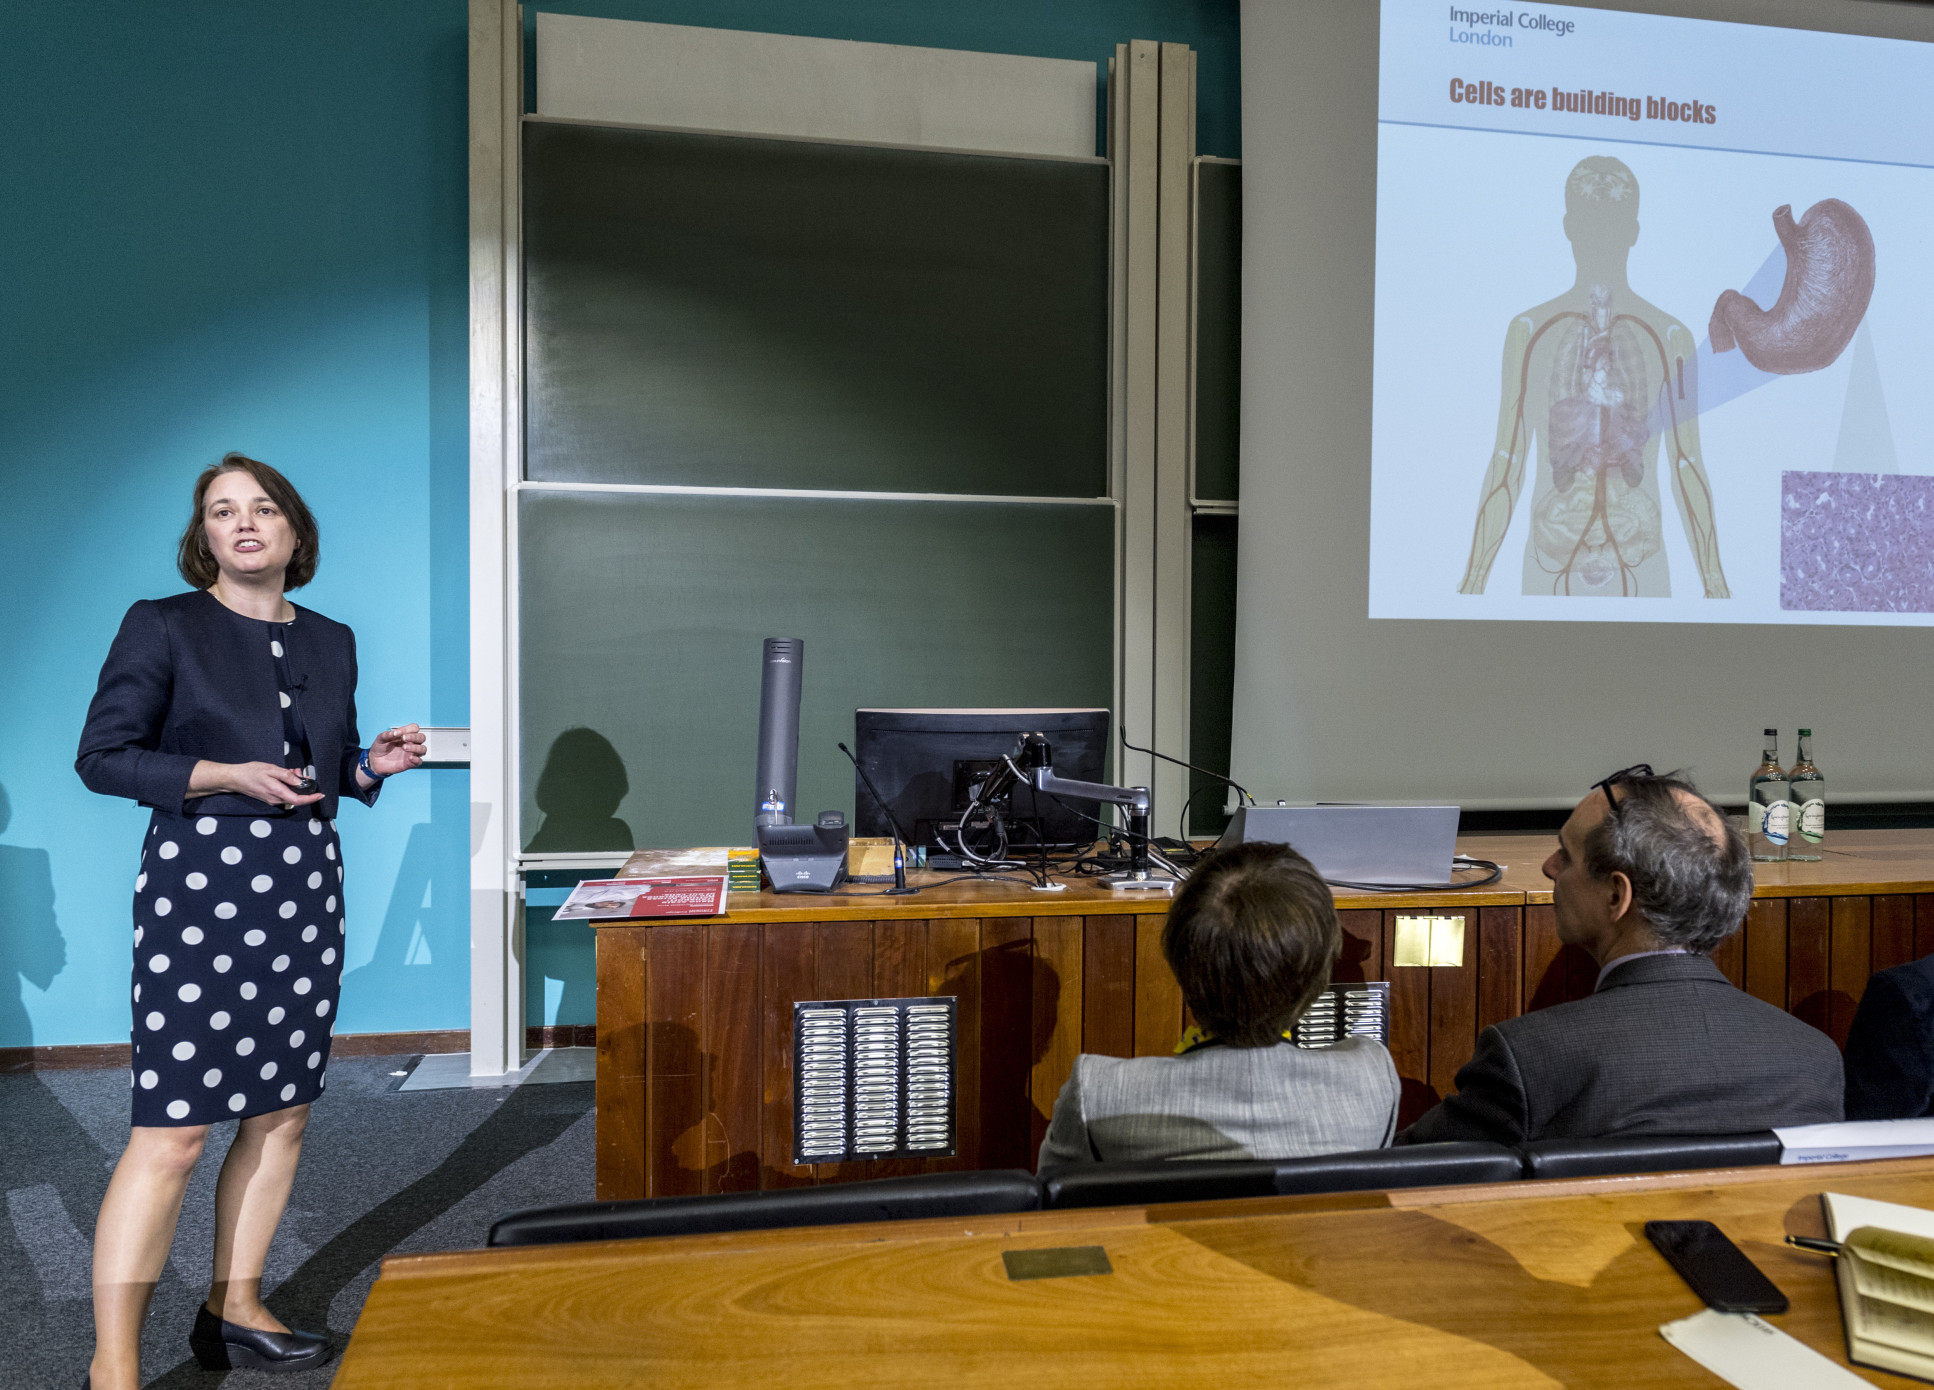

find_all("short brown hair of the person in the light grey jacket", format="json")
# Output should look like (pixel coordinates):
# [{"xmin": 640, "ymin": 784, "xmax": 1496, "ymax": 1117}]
[{"xmin": 1162, "ymin": 843, "xmax": 1342, "ymax": 1048}]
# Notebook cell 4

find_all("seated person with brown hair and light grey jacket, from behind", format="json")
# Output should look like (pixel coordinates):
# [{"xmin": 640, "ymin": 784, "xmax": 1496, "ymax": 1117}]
[{"xmin": 1039, "ymin": 843, "xmax": 1398, "ymax": 1170}]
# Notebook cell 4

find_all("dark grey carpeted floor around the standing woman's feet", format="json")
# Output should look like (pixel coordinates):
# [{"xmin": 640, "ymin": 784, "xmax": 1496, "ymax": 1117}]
[{"xmin": 0, "ymin": 1057, "xmax": 592, "ymax": 1390}]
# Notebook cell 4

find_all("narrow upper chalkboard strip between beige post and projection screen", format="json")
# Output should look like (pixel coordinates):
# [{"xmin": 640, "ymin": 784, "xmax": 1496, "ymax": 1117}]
[{"xmin": 1195, "ymin": 159, "xmax": 1242, "ymax": 503}]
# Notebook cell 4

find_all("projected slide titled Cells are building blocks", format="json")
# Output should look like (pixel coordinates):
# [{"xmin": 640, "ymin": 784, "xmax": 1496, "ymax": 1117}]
[{"xmin": 1369, "ymin": 0, "xmax": 1934, "ymax": 624}]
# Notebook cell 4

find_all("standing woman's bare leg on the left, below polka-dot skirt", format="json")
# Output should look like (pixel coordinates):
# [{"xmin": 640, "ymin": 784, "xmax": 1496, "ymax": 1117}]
[{"xmin": 87, "ymin": 1125, "xmax": 209, "ymax": 1390}]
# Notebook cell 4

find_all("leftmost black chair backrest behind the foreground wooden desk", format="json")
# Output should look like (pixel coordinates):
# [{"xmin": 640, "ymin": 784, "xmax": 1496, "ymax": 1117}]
[{"xmin": 487, "ymin": 1168, "xmax": 1040, "ymax": 1245}]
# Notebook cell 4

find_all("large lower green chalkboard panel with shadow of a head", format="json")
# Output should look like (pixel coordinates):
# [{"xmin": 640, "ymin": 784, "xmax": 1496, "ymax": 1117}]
[{"xmin": 518, "ymin": 489, "xmax": 1114, "ymax": 853}]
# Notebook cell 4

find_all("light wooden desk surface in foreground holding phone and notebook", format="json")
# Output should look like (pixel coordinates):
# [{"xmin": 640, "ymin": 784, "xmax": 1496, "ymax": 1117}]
[{"xmin": 335, "ymin": 1158, "xmax": 1934, "ymax": 1390}]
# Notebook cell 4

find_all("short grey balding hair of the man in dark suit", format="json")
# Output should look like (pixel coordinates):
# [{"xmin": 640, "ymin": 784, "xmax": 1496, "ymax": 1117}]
[{"xmin": 1584, "ymin": 773, "xmax": 1752, "ymax": 955}]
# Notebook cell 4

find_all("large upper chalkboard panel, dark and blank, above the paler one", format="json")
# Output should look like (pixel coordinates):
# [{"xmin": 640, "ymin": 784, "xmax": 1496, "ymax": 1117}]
[{"xmin": 522, "ymin": 120, "xmax": 1108, "ymax": 497}]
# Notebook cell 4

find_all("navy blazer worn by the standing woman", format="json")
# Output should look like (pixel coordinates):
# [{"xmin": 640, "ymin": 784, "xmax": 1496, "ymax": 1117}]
[{"xmin": 73, "ymin": 590, "xmax": 383, "ymax": 820}]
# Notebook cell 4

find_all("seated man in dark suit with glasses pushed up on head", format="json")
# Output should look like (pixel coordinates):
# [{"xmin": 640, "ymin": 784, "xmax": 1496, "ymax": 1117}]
[{"xmin": 1396, "ymin": 767, "xmax": 1841, "ymax": 1144}]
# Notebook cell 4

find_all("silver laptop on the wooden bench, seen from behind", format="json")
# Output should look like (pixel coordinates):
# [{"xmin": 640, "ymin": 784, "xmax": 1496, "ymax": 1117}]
[{"xmin": 1218, "ymin": 806, "xmax": 1458, "ymax": 885}]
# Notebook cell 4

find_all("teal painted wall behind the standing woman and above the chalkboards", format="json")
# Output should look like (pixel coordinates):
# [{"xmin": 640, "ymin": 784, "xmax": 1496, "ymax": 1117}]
[{"xmin": 0, "ymin": 0, "xmax": 1242, "ymax": 1048}]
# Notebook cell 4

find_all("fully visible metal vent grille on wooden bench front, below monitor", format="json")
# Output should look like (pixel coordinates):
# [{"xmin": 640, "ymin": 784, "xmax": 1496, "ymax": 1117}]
[{"xmin": 793, "ymin": 996, "xmax": 955, "ymax": 1164}]
